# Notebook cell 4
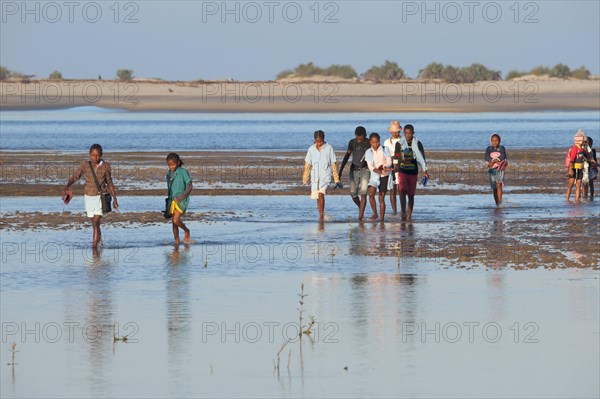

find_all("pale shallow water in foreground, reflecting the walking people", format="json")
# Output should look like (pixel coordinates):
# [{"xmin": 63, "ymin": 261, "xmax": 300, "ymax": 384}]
[{"xmin": 0, "ymin": 195, "xmax": 600, "ymax": 397}]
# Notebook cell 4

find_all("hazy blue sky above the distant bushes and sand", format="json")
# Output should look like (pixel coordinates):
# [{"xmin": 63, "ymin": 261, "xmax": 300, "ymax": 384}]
[{"xmin": 0, "ymin": 0, "xmax": 600, "ymax": 80}]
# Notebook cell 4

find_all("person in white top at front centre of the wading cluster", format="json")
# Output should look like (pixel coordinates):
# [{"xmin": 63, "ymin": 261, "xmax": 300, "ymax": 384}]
[{"xmin": 365, "ymin": 133, "xmax": 392, "ymax": 222}]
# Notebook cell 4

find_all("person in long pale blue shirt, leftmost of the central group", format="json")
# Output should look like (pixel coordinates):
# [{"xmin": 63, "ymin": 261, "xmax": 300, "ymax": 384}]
[{"xmin": 302, "ymin": 130, "xmax": 340, "ymax": 221}]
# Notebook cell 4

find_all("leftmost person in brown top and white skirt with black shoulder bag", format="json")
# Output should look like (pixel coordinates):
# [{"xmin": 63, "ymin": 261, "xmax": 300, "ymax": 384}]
[{"xmin": 62, "ymin": 144, "xmax": 119, "ymax": 250}]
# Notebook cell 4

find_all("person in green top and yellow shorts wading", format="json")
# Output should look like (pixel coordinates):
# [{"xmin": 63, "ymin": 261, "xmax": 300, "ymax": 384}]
[{"xmin": 167, "ymin": 152, "xmax": 192, "ymax": 244}]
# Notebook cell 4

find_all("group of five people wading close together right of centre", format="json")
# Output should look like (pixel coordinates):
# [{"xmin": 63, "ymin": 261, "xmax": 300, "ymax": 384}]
[{"xmin": 302, "ymin": 121, "xmax": 429, "ymax": 222}]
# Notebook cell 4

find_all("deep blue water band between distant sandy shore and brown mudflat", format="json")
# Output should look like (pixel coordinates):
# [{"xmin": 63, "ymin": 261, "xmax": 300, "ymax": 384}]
[{"xmin": 0, "ymin": 107, "xmax": 600, "ymax": 152}]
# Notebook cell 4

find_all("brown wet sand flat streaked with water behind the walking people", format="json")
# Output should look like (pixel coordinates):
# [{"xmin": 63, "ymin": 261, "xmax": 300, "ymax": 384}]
[{"xmin": 0, "ymin": 149, "xmax": 567, "ymax": 196}]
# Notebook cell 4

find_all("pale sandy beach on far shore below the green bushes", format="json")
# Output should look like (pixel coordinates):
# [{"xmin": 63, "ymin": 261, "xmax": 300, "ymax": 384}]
[{"xmin": 0, "ymin": 79, "xmax": 600, "ymax": 112}]
